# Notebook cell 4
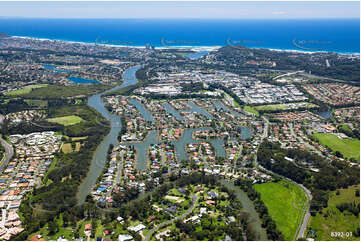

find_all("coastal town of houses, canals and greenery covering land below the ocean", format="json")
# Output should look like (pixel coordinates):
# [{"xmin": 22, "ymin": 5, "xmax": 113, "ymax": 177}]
[{"xmin": 0, "ymin": 32, "xmax": 360, "ymax": 241}]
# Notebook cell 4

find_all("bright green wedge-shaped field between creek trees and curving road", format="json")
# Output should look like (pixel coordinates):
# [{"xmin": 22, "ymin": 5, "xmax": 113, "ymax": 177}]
[{"xmin": 254, "ymin": 181, "xmax": 307, "ymax": 240}]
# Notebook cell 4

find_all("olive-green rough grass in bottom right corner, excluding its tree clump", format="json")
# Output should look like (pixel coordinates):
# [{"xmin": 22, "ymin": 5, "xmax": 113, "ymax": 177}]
[{"xmin": 308, "ymin": 185, "xmax": 360, "ymax": 241}]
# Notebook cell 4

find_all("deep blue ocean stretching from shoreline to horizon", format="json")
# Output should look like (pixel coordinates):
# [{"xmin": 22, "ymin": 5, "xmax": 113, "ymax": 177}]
[{"xmin": 0, "ymin": 18, "xmax": 360, "ymax": 53}]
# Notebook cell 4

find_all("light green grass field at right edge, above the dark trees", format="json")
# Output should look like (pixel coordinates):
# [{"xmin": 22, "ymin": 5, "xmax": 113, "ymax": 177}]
[{"xmin": 313, "ymin": 133, "xmax": 360, "ymax": 161}]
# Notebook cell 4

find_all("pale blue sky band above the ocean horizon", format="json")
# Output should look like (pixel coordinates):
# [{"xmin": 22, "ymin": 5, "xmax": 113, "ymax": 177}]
[{"xmin": 0, "ymin": 1, "xmax": 360, "ymax": 19}]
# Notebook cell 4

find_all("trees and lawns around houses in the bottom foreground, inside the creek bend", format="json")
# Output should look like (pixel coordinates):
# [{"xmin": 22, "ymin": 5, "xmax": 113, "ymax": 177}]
[{"xmin": 18, "ymin": 173, "xmax": 254, "ymax": 241}]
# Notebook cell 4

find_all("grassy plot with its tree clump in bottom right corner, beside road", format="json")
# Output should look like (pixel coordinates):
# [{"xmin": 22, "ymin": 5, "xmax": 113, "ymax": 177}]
[{"xmin": 308, "ymin": 185, "xmax": 360, "ymax": 241}]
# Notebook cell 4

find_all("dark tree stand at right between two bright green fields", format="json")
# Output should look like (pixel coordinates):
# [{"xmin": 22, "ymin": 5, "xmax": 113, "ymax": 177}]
[{"xmin": 257, "ymin": 141, "xmax": 360, "ymax": 216}]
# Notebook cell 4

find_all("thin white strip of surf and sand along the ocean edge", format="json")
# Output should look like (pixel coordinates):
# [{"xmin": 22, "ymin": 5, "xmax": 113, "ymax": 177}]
[{"xmin": 10, "ymin": 36, "xmax": 360, "ymax": 56}]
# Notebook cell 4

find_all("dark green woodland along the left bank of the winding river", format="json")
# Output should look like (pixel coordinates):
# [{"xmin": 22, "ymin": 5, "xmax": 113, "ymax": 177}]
[{"xmin": 14, "ymin": 103, "xmax": 109, "ymax": 240}]
